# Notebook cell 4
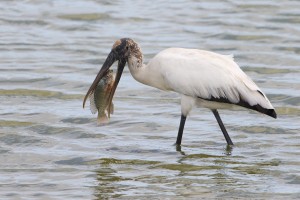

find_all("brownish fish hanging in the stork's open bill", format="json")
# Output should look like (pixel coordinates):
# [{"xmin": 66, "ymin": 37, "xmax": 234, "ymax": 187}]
[{"xmin": 89, "ymin": 70, "xmax": 115, "ymax": 124}]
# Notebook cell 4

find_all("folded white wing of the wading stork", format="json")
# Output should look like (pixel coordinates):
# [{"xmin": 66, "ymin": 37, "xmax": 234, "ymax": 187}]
[{"xmin": 151, "ymin": 48, "xmax": 273, "ymax": 112}]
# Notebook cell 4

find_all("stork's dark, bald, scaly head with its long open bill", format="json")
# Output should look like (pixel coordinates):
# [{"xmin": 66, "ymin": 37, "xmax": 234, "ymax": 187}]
[{"xmin": 83, "ymin": 38, "xmax": 142, "ymax": 107}]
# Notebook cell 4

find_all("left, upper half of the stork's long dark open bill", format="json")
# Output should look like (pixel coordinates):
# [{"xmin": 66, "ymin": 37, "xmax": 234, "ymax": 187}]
[{"xmin": 82, "ymin": 51, "xmax": 116, "ymax": 108}]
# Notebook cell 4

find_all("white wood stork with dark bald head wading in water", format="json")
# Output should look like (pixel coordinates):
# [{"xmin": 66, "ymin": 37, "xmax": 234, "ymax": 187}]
[{"xmin": 83, "ymin": 38, "xmax": 276, "ymax": 145}]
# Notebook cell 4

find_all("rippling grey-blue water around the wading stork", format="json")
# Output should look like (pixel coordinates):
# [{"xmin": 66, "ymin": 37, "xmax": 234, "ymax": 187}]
[{"xmin": 0, "ymin": 0, "xmax": 300, "ymax": 199}]
